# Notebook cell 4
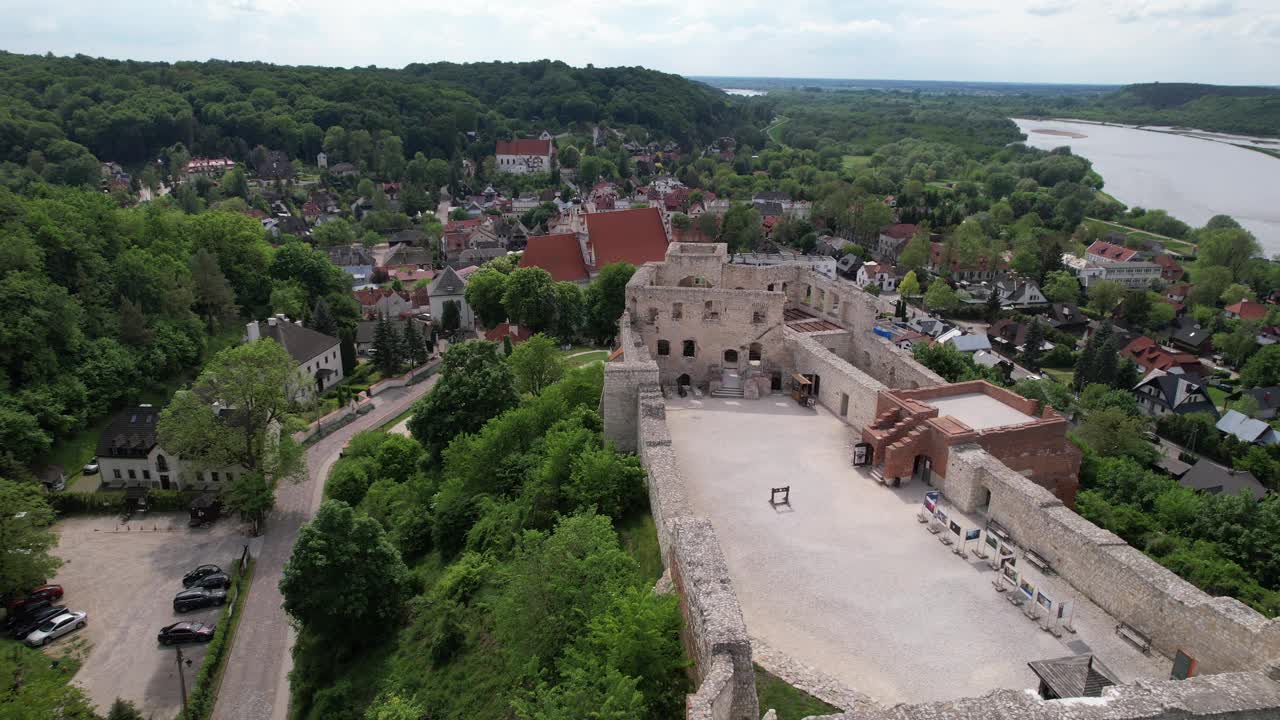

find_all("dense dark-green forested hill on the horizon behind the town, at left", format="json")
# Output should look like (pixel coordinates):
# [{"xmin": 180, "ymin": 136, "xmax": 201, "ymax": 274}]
[{"xmin": 0, "ymin": 53, "xmax": 739, "ymax": 172}]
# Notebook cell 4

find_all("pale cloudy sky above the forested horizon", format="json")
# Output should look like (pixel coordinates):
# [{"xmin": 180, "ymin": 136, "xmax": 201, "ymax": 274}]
[{"xmin": 0, "ymin": 0, "xmax": 1280, "ymax": 85}]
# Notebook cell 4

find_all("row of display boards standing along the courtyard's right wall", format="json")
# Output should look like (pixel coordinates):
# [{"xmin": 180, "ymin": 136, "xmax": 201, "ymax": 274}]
[{"xmin": 916, "ymin": 491, "xmax": 1075, "ymax": 637}]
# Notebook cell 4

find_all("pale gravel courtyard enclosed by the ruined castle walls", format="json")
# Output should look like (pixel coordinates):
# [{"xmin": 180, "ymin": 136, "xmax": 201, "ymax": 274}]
[{"xmin": 667, "ymin": 395, "xmax": 1170, "ymax": 705}]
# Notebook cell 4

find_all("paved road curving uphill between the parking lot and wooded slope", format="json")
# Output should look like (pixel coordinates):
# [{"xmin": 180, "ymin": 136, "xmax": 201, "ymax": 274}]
[{"xmin": 214, "ymin": 375, "xmax": 439, "ymax": 720}]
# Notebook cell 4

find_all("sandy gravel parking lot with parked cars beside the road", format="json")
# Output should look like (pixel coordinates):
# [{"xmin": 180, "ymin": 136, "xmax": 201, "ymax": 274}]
[{"xmin": 50, "ymin": 512, "xmax": 248, "ymax": 717}]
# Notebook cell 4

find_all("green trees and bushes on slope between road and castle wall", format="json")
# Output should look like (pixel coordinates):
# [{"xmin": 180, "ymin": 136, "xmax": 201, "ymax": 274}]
[{"xmin": 280, "ymin": 353, "xmax": 689, "ymax": 720}]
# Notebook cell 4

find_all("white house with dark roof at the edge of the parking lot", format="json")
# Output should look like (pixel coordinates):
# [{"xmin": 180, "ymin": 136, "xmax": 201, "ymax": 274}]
[{"xmin": 97, "ymin": 405, "xmax": 246, "ymax": 489}]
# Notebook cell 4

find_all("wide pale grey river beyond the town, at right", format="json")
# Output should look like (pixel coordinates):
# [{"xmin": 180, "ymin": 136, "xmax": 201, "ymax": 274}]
[{"xmin": 1014, "ymin": 118, "xmax": 1280, "ymax": 256}]
